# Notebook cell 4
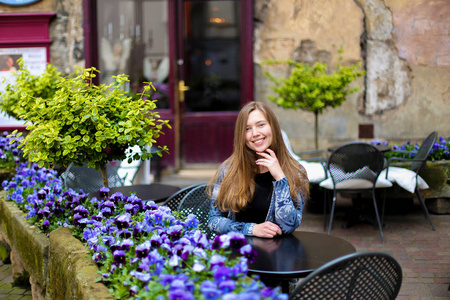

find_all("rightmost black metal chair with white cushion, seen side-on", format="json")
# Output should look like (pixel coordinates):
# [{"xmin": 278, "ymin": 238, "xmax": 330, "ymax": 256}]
[{"xmin": 381, "ymin": 131, "xmax": 438, "ymax": 230}]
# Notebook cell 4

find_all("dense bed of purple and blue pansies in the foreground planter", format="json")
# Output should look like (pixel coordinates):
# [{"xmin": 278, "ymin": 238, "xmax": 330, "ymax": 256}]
[{"xmin": 2, "ymin": 164, "xmax": 287, "ymax": 299}]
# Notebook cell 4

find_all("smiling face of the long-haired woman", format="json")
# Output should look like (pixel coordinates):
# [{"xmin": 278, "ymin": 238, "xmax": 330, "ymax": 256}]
[{"xmin": 245, "ymin": 110, "xmax": 272, "ymax": 152}]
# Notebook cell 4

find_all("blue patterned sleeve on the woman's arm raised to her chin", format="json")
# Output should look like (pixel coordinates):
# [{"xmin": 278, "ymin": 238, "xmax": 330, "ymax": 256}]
[{"xmin": 268, "ymin": 177, "xmax": 305, "ymax": 234}]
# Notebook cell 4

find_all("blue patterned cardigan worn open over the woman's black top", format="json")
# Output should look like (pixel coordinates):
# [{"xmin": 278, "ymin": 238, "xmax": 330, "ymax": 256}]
[{"xmin": 208, "ymin": 169, "xmax": 305, "ymax": 236}]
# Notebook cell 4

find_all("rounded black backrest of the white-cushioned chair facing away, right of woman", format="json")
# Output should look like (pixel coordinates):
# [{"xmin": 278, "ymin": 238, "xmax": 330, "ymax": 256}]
[{"xmin": 327, "ymin": 142, "xmax": 384, "ymax": 185}]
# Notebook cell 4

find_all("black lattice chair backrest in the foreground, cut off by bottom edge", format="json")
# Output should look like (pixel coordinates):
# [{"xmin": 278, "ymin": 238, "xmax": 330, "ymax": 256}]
[{"xmin": 289, "ymin": 252, "xmax": 402, "ymax": 299}]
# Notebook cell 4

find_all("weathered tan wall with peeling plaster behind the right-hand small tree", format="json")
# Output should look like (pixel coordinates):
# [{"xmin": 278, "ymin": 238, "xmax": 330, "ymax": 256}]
[{"xmin": 254, "ymin": 0, "xmax": 450, "ymax": 151}]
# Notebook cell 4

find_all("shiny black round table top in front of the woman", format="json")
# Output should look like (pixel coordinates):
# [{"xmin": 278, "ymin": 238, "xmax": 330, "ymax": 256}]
[{"xmin": 247, "ymin": 231, "xmax": 356, "ymax": 279}]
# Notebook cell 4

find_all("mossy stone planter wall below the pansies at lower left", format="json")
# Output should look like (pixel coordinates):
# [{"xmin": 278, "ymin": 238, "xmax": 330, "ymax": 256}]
[{"xmin": 0, "ymin": 191, "xmax": 113, "ymax": 300}]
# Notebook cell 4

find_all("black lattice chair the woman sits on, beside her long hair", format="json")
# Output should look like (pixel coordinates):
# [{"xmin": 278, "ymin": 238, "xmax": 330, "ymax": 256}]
[{"xmin": 178, "ymin": 184, "xmax": 215, "ymax": 238}]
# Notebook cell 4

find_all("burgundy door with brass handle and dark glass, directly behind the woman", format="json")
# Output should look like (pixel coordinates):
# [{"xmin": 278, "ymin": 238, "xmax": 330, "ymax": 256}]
[{"xmin": 175, "ymin": 0, "xmax": 253, "ymax": 167}]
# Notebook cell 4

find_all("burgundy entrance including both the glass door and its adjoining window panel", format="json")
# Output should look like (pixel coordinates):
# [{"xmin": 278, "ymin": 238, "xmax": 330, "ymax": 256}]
[{"xmin": 91, "ymin": 0, "xmax": 253, "ymax": 169}]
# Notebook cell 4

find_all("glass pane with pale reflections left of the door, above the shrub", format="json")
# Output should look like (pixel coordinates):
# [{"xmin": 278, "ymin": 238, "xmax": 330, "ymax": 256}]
[{"xmin": 97, "ymin": 0, "xmax": 169, "ymax": 108}]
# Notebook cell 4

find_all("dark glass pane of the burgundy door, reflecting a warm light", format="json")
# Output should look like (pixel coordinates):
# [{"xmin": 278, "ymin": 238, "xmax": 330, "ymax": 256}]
[{"xmin": 184, "ymin": 1, "xmax": 240, "ymax": 112}]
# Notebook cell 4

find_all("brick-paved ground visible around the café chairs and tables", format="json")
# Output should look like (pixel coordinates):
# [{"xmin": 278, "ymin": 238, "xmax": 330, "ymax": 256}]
[{"xmin": 0, "ymin": 172, "xmax": 450, "ymax": 300}]
